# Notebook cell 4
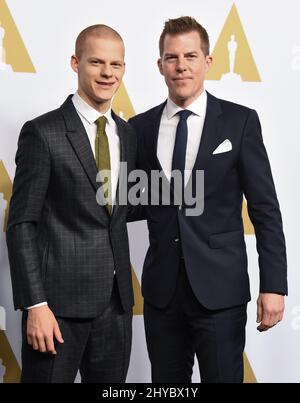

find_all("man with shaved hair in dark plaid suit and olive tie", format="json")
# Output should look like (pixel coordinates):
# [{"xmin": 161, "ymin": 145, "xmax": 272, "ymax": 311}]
[{"xmin": 7, "ymin": 25, "xmax": 136, "ymax": 382}]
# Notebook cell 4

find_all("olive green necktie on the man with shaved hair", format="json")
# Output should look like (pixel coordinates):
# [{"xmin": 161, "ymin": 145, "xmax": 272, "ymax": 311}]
[{"xmin": 95, "ymin": 116, "xmax": 112, "ymax": 214}]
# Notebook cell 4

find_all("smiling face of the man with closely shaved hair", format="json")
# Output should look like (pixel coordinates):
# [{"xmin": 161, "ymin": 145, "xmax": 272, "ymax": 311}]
[{"xmin": 71, "ymin": 36, "xmax": 125, "ymax": 113}]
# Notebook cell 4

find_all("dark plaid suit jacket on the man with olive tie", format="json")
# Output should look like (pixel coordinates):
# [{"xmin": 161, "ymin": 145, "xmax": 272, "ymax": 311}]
[{"xmin": 7, "ymin": 96, "xmax": 136, "ymax": 318}]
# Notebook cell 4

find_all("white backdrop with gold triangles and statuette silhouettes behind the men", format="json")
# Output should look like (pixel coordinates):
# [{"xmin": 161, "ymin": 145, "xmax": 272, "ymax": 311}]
[{"xmin": 0, "ymin": 0, "xmax": 300, "ymax": 382}]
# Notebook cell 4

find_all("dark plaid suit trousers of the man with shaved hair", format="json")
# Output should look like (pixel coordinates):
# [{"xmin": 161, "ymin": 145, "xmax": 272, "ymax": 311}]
[{"xmin": 21, "ymin": 281, "xmax": 132, "ymax": 383}]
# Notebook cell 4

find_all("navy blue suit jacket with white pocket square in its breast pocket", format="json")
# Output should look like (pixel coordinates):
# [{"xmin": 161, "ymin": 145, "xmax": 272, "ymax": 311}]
[{"xmin": 129, "ymin": 94, "xmax": 287, "ymax": 309}]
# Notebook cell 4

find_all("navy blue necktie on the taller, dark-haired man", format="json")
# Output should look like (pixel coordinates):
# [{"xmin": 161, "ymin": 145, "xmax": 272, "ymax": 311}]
[{"xmin": 172, "ymin": 109, "xmax": 192, "ymax": 178}]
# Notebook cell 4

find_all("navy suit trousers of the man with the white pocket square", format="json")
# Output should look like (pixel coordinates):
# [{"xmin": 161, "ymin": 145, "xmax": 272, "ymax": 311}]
[{"xmin": 144, "ymin": 260, "xmax": 247, "ymax": 383}]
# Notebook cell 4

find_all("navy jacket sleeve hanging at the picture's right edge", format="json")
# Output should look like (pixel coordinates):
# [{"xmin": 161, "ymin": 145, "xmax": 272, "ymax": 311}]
[{"xmin": 239, "ymin": 110, "xmax": 287, "ymax": 294}]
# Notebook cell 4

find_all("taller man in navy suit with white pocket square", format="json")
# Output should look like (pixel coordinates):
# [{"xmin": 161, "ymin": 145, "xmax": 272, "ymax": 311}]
[{"xmin": 130, "ymin": 17, "xmax": 287, "ymax": 382}]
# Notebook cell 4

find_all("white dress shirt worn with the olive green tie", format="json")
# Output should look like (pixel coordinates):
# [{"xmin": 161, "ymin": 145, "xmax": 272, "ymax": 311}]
[{"xmin": 26, "ymin": 92, "xmax": 120, "ymax": 309}]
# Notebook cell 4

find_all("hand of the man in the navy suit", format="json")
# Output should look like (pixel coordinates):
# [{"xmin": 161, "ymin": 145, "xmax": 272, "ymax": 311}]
[{"xmin": 256, "ymin": 293, "xmax": 284, "ymax": 332}]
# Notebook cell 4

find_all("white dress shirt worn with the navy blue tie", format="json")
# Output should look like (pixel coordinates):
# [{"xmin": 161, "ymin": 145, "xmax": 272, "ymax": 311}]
[{"xmin": 157, "ymin": 91, "xmax": 207, "ymax": 185}]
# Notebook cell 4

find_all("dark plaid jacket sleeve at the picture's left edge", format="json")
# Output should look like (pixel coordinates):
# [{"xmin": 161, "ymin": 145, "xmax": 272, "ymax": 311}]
[{"xmin": 6, "ymin": 122, "xmax": 50, "ymax": 309}]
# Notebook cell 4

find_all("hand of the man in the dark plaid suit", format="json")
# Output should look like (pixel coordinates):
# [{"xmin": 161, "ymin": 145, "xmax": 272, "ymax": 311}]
[{"xmin": 27, "ymin": 305, "xmax": 64, "ymax": 354}]
